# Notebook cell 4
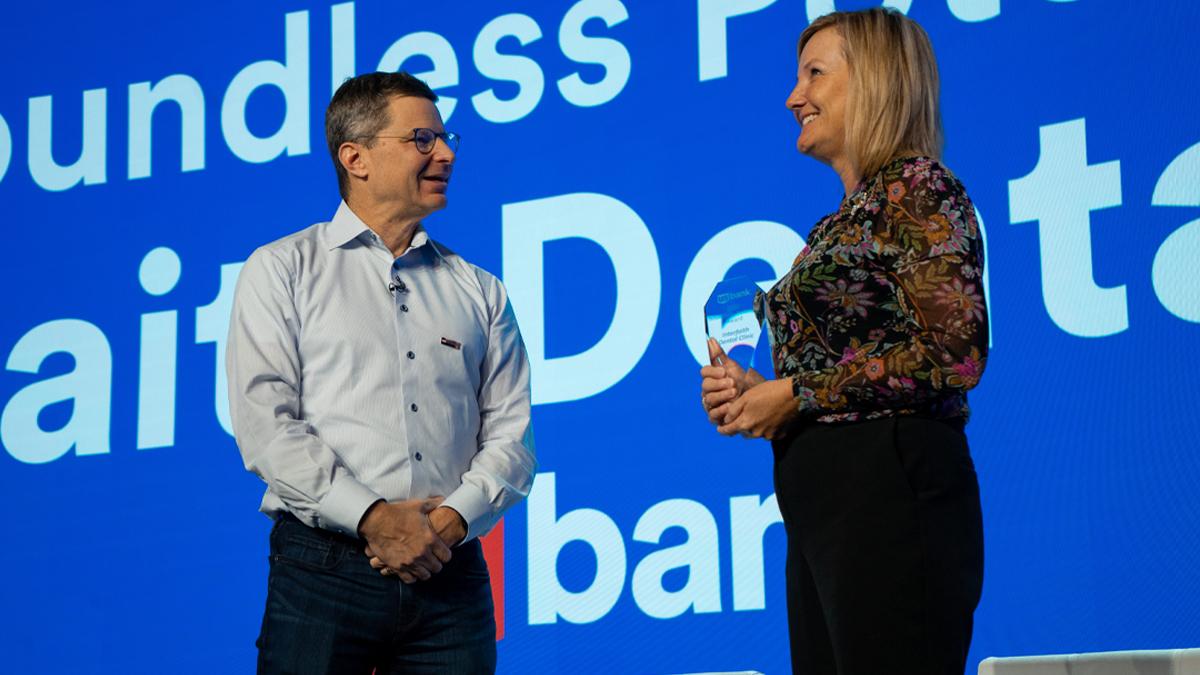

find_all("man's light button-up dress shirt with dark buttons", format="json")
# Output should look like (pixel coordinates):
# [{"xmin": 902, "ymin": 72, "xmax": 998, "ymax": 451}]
[{"xmin": 226, "ymin": 202, "xmax": 536, "ymax": 539}]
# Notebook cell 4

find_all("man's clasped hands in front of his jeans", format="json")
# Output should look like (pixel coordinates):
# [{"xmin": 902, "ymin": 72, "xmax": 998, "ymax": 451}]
[{"xmin": 359, "ymin": 497, "xmax": 467, "ymax": 584}]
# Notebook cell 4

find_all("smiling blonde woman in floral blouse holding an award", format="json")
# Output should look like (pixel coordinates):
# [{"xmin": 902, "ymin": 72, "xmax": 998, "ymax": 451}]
[{"xmin": 701, "ymin": 8, "xmax": 988, "ymax": 675}]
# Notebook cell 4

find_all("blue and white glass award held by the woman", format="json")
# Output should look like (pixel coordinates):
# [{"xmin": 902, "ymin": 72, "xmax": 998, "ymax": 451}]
[{"xmin": 704, "ymin": 276, "xmax": 775, "ymax": 380}]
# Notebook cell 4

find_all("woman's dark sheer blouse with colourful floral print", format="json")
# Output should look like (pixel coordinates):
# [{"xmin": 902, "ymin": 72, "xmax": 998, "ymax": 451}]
[{"xmin": 764, "ymin": 157, "xmax": 988, "ymax": 422}]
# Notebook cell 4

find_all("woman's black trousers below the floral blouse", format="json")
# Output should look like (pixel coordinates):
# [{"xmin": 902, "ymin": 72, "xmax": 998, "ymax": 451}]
[{"xmin": 773, "ymin": 417, "xmax": 983, "ymax": 675}]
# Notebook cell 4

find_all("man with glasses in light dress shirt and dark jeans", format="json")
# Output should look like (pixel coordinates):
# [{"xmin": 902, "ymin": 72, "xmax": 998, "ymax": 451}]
[{"xmin": 226, "ymin": 73, "xmax": 535, "ymax": 674}]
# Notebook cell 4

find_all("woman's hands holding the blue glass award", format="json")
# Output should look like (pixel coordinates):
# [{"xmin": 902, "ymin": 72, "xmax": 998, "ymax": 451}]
[{"xmin": 700, "ymin": 338, "xmax": 798, "ymax": 440}]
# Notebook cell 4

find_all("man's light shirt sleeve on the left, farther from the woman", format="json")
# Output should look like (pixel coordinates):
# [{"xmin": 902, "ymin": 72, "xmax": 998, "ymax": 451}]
[{"xmin": 226, "ymin": 243, "xmax": 382, "ymax": 536}]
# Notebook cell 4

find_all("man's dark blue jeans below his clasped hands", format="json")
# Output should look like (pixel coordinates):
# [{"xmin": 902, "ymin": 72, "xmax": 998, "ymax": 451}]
[{"xmin": 258, "ymin": 515, "xmax": 496, "ymax": 675}]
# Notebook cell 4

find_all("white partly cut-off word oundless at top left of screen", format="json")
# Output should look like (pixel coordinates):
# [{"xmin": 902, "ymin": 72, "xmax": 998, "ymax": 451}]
[{"xmin": 0, "ymin": 0, "xmax": 631, "ymax": 191}]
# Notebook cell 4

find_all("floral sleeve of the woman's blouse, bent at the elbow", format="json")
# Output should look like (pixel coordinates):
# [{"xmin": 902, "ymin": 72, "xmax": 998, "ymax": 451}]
[{"xmin": 792, "ymin": 162, "xmax": 988, "ymax": 417}]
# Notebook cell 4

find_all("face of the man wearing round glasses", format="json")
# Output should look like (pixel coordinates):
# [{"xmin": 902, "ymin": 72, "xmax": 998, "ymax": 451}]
[{"xmin": 364, "ymin": 96, "xmax": 455, "ymax": 217}]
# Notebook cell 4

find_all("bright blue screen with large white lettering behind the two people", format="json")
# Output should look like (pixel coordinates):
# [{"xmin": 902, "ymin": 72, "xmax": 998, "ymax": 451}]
[{"xmin": 0, "ymin": 0, "xmax": 1200, "ymax": 674}]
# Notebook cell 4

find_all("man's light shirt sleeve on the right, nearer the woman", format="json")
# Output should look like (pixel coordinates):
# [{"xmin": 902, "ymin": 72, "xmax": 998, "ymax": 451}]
[{"xmin": 443, "ymin": 270, "xmax": 538, "ymax": 540}]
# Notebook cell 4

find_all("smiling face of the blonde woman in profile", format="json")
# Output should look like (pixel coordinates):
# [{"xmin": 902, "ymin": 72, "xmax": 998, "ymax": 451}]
[{"xmin": 787, "ymin": 28, "xmax": 850, "ymax": 166}]
